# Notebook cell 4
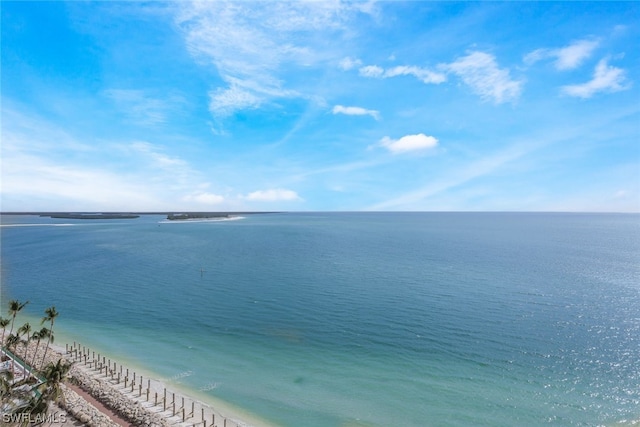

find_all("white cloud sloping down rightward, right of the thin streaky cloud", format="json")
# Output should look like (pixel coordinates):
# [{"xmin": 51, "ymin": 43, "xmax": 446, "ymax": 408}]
[{"xmin": 442, "ymin": 52, "xmax": 523, "ymax": 104}]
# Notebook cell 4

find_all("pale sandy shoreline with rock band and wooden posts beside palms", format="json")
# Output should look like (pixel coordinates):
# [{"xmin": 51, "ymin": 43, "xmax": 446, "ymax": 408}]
[{"xmin": 3, "ymin": 342, "xmax": 273, "ymax": 427}]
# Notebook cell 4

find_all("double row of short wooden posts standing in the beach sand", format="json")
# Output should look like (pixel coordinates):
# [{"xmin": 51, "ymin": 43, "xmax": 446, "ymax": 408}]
[{"xmin": 65, "ymin": 341, "xmax": 237, "ymax": 427}]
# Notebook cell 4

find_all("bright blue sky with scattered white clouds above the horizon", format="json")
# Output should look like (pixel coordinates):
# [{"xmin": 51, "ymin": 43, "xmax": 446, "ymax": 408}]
[{"xmin": 0, "ymin": 1, "xmax": 640, "ymax": 212}]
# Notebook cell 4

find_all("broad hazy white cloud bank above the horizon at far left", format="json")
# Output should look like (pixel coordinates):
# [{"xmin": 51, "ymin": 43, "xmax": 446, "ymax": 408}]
[{"xmin": 0, "ymin": 106, "xmax": 228, "ymax": 210}]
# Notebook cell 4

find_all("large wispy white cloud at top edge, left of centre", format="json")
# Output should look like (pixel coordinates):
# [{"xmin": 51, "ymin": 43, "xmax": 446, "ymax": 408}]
[{"xmin": 176, "ymin": 1, "xmax": 371, "ymax": 118}]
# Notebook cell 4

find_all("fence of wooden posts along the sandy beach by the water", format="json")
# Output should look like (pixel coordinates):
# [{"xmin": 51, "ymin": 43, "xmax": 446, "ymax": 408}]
[{"xmin": 65, "ymin": 341, "xmax": 245, "ymax": 427}]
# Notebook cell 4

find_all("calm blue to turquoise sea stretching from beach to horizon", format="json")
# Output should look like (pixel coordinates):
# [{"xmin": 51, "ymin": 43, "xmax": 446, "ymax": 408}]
[{"xmin": 1, "ymin": 213, "xmax": 640, "ymax": 427}]
